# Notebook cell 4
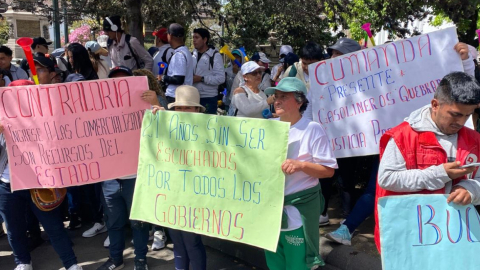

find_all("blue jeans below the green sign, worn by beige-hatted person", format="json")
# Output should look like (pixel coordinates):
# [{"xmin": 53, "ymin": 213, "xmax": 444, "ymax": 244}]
[{"xmin": 168, "ymin": 228, "xmax": 207, "ymax": 270}]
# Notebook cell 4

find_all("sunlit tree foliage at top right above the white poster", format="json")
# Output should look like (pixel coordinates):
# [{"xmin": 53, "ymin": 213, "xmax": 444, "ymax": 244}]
[{"xmin": 324, "ymin": 0, "xmax": 480, "ymax": 44}]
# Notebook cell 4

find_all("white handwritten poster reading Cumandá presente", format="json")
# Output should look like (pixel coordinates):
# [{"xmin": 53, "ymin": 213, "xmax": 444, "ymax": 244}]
[{"xmin": 309, "ymin": 27, "xmax": 463, "ymax": 158}]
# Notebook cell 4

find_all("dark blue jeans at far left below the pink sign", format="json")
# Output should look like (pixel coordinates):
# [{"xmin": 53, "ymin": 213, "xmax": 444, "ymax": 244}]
[{"xmin": 0, "ymin": 181, "xmax": 77, "ymax": 269}]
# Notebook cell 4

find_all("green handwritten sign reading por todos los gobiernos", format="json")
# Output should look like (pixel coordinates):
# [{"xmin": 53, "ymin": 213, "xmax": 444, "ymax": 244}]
[{"xmin": 130, "ymin": 111, "xmax": 289, "ymax": 251}]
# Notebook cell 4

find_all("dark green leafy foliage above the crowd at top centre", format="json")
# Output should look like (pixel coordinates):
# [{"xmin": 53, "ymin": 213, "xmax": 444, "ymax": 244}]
[{"xmin": 221, "ymin": 0, "xmax": 332, "ymax": 51}]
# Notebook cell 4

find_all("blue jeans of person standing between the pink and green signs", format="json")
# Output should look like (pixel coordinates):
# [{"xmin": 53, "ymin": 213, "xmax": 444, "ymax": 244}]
[{"xmin": 102, "ymin": 178, "xmax": 150, "ymax": 263}]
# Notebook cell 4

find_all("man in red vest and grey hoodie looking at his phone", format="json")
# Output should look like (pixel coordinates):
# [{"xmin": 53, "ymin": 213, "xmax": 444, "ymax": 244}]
[{"xmin": 375, "ymin": 72, "xmax": 480, "ymax": 252}]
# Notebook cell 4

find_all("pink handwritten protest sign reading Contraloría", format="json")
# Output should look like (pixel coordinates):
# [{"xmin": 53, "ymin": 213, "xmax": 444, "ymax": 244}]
[{"xmin": 0, "ymin": 77, "xmax": 150, "ymax": 190}]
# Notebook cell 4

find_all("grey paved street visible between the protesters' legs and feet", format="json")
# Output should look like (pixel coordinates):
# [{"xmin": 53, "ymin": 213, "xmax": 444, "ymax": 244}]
[{"xmin": 0, "ymin": 192, "xmax": 380, "ymax": 270}]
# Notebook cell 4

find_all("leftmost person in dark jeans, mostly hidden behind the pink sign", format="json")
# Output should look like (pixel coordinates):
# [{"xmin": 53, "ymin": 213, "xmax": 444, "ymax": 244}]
[{"xmin": 0, "ymin": 79, "xmax": 82, "ymax": 270}]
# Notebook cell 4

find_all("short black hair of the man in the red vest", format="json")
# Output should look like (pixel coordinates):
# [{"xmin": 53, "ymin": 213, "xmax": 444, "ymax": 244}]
[{"xmin": 434, "ymin": 71, "xmax": 480, "ymax": 105}]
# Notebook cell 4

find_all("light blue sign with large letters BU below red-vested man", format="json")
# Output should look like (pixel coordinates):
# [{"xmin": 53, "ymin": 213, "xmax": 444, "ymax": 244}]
[{"xmin": 378, "ymin": 195, "xmax": 480, "ymax": 270}]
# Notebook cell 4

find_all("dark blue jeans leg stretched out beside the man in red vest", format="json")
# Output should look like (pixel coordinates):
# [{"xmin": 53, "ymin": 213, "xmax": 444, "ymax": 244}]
[{"xmin": 343, "ymin": 155, "xmax": 380, "ymax": 233}]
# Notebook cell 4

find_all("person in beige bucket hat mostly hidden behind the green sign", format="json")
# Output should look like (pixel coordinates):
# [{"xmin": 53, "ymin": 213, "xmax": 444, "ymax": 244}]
[{"xmin": 152, "ymin": 85, "xmax": 207, "ymax": 270}]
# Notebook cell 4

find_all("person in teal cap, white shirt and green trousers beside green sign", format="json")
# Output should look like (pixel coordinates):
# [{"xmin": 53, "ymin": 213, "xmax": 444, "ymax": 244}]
[{"xmin": 265, "ymin": 77, "xmax": 337, "ymax": 270}]
